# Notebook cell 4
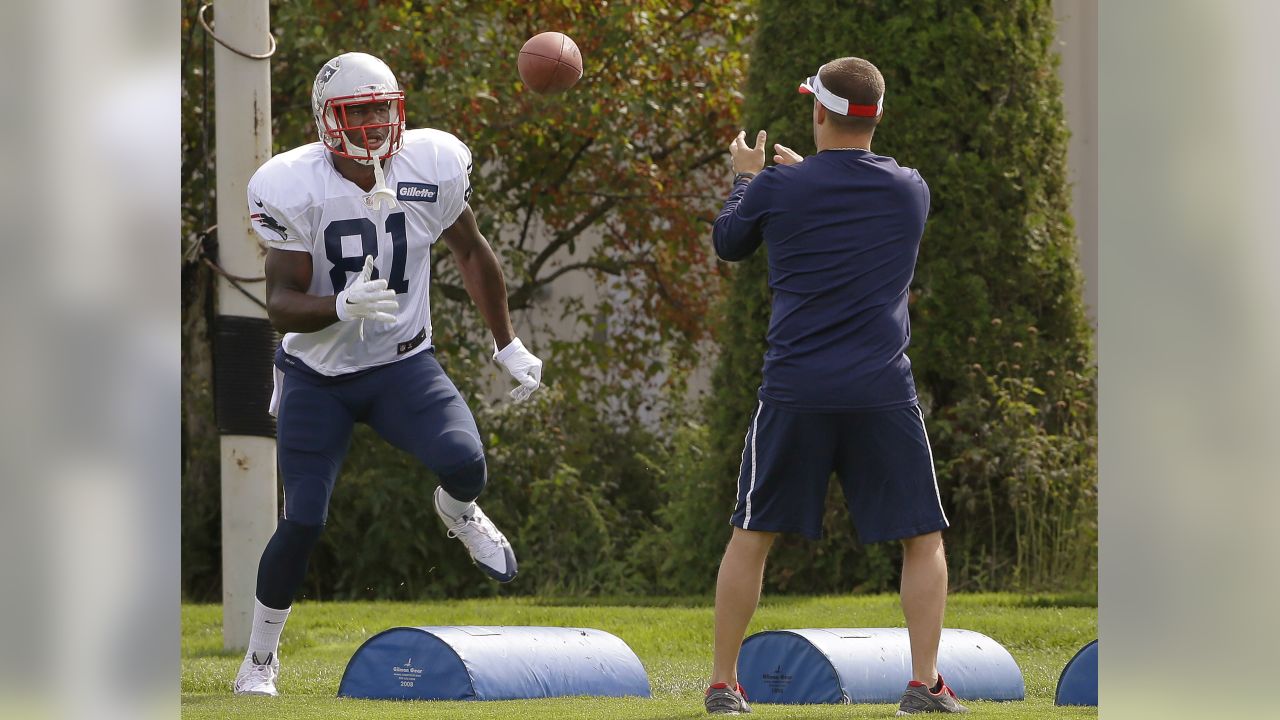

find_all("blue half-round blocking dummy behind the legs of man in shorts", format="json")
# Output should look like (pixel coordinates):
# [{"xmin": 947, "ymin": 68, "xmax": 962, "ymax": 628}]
[{"xmin": 737, "ymin": 628, "xmax": 1027, "ymax": 703}]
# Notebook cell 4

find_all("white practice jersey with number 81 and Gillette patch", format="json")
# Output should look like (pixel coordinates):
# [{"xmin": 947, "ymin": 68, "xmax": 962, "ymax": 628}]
[{"xmin": 248, "ymin": 128, "xmax": 471, "ymax": 375}]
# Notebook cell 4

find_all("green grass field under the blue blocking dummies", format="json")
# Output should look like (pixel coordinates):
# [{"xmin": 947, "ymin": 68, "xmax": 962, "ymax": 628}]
[{"xmin": 182, "ymin": 594, "xmax": 1098, "ymax": 720}]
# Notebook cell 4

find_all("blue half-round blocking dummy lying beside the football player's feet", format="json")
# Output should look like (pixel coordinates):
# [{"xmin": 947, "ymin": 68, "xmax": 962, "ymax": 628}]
[{"xmin": 338, "ymin": 625, "xmax": 650, "ymax": 700}]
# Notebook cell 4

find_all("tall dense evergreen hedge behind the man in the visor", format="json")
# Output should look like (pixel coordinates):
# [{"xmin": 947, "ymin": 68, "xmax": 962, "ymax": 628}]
[{"xmin": 699, "ymin": 0, "xmax": 1097, "ymax": 592}]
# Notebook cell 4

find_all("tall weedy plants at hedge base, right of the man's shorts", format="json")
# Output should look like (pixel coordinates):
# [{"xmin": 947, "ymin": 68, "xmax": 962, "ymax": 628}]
[{"xmin": 932, "ymin": 370, "xmax": 1098, "ymax": 589}]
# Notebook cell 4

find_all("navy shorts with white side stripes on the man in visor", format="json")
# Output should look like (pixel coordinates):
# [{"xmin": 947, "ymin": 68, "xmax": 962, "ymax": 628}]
[{"xmin": 730, "ymin": 401, "xmax": 947, "ymax": 543}]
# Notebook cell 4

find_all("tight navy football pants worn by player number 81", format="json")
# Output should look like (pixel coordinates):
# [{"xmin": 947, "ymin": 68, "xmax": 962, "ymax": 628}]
[{"xmin": 275, "ymin": 340, "xmax": 484, "ymax": 525}]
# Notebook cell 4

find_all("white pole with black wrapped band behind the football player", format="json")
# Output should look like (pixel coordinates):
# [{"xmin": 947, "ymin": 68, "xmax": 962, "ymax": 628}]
[{"xmin": 214, "ymin": 0, "xmax": 276, "ymax": 650}]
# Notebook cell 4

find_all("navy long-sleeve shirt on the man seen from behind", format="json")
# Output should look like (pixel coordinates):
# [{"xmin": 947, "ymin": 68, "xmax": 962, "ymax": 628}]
[{"xmin": 713, "ymin": 150, "xmax": 929, "ymax": 411}]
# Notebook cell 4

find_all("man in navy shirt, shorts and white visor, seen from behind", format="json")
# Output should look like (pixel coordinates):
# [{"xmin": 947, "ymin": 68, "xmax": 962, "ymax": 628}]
[{"xmin": 707, "ymin": 58, "xmax": 966, "ymax": 715}]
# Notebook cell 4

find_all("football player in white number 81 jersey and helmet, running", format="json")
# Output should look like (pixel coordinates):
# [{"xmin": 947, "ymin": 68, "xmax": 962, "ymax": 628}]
[{"xmin": 233, "ymin": 53, "xmax": 543, "ymax": 696}]
